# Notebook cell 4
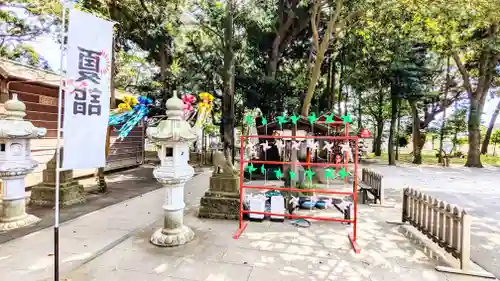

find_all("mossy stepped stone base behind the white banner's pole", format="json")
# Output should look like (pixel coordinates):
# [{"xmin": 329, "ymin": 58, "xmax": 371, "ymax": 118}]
[{"xmin": 30, "ymin": 148, "xmax": 86, "ymax": 207}]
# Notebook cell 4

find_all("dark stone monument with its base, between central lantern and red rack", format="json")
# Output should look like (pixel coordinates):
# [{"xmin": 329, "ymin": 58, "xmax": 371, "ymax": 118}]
[{"xmin": 198, "ymin": 151, "xmax": 240, "ymax": 220}]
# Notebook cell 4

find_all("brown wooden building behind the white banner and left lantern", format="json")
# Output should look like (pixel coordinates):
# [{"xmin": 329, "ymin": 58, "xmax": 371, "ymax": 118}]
[{"xmin": 0, "ymin": 58, "xmax": 145, "ymax": 186}]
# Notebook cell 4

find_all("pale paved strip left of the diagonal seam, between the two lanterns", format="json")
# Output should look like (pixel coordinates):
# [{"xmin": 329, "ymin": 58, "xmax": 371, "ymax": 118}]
[{"xmin": 0, "ymin": 168, "xmax": 208, "ymax": 281}]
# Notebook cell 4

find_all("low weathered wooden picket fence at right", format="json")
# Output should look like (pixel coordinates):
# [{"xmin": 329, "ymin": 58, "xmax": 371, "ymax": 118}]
[{"xmin": 402, "ymin": 187, "xmax": 472, "ymax": 270}]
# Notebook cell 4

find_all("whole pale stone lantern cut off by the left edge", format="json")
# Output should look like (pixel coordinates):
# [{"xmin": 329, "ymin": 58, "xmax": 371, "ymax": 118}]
[{"xmin": 0, "ymin": 94, "xmax": 47, "ymax": 231}]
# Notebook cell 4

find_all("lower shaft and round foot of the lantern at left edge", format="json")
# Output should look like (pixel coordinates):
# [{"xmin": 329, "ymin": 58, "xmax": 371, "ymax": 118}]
[{"xmin": 0, "ymin": 172, "xmax": 40, "ymax": 232}]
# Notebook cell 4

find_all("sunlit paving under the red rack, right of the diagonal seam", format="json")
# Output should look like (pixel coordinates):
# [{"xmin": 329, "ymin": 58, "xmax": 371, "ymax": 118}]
[{"xmin": 61, "ymin": 177, "xmax": 492, "ymax": 281}]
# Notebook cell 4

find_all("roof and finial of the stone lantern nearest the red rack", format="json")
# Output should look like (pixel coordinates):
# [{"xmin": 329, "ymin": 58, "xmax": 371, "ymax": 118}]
[{"xmin": 146, "ymin": 91, "xmax": 197, "ymax": 141}]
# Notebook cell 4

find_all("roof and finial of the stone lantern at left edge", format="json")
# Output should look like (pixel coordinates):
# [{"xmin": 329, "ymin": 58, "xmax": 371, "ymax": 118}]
[{"xmin": 0, "ymin": 94, "xmax": 47, "ymax": 139}]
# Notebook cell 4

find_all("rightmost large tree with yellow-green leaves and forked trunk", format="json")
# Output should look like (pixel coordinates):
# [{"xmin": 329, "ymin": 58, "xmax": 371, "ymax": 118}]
[{"xmin": 412, "ymin": 0, "xmax": 500, "ymax": 168}]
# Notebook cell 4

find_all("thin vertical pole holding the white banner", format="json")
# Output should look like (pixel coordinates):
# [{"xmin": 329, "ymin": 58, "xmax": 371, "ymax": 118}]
[{"xmin": 54, "ymin": 2, "xmax": 66, "ymax": 281}]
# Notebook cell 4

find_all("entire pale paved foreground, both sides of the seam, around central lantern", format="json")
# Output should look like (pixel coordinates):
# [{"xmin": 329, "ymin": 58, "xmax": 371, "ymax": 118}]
[{"xmin": 0, "ymin": 164, "xmax": 498, "ymax": 281}]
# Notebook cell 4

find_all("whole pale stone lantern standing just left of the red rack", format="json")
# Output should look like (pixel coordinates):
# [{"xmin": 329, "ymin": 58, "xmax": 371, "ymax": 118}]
[{"xmin": 146, "ymin": 92, "xmax": 197, "ymax": 247}]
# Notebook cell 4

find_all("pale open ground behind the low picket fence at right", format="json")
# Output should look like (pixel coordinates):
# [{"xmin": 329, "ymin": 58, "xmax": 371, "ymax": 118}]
[{"xmin": 367, "ymin": 164, "xmax": 500, "ymax": 278}]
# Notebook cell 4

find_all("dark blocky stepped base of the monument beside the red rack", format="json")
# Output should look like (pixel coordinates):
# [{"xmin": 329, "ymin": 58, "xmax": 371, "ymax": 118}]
[{"xmin": 198, "ymin": 174, "xmax": 240, "ymax": 220}]
